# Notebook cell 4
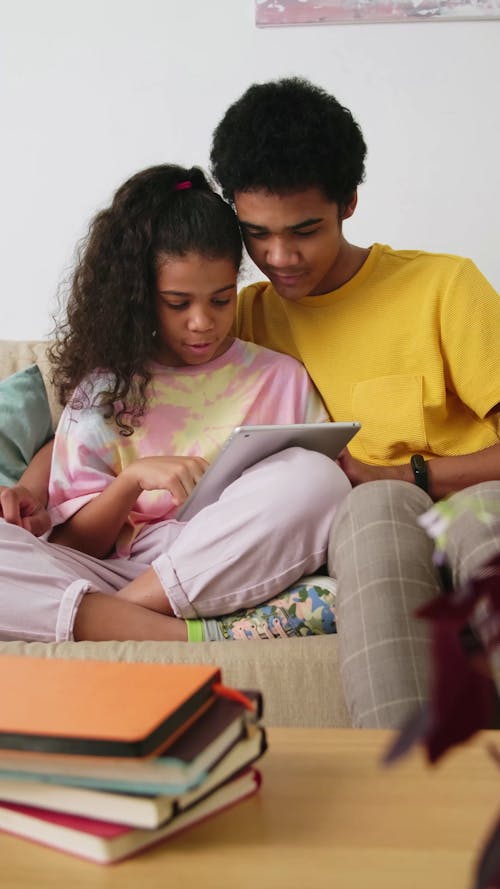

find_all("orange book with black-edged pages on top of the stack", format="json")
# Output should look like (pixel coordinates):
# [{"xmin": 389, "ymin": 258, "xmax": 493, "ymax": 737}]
[{"xmin": 0, "ymin": 655, "xmax": 220, "ymax": 757}]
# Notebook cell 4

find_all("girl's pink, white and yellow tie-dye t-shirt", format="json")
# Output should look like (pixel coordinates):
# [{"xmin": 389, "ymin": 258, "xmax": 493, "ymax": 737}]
[{"xmin": 49, "ymin": 340, "xmax": 328, "ymax": 555}]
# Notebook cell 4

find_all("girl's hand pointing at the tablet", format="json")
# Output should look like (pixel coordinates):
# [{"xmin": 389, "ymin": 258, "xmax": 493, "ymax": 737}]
[{"xmin": 127, "ymin": 457, "xmax": 208, "ymax": 506}]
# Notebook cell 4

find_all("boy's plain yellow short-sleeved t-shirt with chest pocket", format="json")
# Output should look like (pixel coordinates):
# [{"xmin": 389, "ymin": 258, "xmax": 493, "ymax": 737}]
[{"xmin": 237, "ymin": 244, "xmax": 500, "ymax": 465}]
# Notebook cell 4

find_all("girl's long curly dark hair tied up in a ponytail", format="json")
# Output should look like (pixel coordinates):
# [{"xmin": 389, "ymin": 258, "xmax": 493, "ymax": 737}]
[{"xmin": 50, "ymin": 164, "xmax": 242, "ymax": 435}]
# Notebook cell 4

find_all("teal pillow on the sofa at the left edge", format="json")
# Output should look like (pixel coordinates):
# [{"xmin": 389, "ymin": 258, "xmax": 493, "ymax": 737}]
[{"xmin": 0, "ymin": 364, "xmax": 53, "ymax": 485}]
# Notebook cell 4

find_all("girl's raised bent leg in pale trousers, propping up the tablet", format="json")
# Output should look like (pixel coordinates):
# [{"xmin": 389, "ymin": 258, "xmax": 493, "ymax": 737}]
[{"xmin": 118, "ymin": 448, "xmax": 351, "ymax": 619}]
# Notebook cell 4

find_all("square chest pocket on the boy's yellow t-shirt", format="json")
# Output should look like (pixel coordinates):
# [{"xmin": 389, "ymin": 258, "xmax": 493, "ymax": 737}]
[{"xmin": 352, "ymin": 374, "xmax": 428, "ymax": 462}]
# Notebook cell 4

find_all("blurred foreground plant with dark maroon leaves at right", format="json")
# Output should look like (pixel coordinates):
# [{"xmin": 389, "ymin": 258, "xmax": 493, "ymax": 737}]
[{"xmin": 384, "ymin": 501, "xmax": 500, "ymax": 889}]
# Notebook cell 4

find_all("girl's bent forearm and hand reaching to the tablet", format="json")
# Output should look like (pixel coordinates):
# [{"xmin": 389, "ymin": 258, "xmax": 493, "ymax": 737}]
[{"xmin": 50, "ymin": 457, "xmax": 208, "ymax": 559}]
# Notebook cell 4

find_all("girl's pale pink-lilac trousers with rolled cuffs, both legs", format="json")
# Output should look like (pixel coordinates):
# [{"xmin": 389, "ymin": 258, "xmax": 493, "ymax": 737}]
[{"xmin": 0, "ymin": 448, "xmax": 351, "ymax": 642}]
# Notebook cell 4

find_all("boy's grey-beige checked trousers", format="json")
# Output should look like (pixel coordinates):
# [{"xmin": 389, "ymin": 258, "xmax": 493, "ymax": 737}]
[{"xmin": 328, "ymin": 481, "xmax": 500, "ymax": 728}]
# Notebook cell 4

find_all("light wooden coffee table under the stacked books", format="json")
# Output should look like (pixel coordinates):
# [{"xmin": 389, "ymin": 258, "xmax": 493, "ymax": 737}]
[{"xmin": 0, "ymin": 729, "xmax": 500, "ymax": 889}]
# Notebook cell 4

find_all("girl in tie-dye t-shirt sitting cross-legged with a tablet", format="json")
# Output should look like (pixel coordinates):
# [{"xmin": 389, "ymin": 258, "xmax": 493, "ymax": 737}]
[{"xmin": 3, "ymin": 165, "xmax": 350, "ymax": 641}]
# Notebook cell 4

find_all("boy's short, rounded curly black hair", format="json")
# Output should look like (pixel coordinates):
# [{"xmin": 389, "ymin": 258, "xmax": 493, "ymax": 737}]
[{"xmin": 210, "ymin": 77, "xmax": 366, "ymax": 206}]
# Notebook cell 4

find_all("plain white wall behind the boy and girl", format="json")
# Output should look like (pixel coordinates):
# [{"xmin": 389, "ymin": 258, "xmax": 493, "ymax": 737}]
[{"xmin": 0, "ymin": 0, "xmax": 500, "ymax": 339}]
